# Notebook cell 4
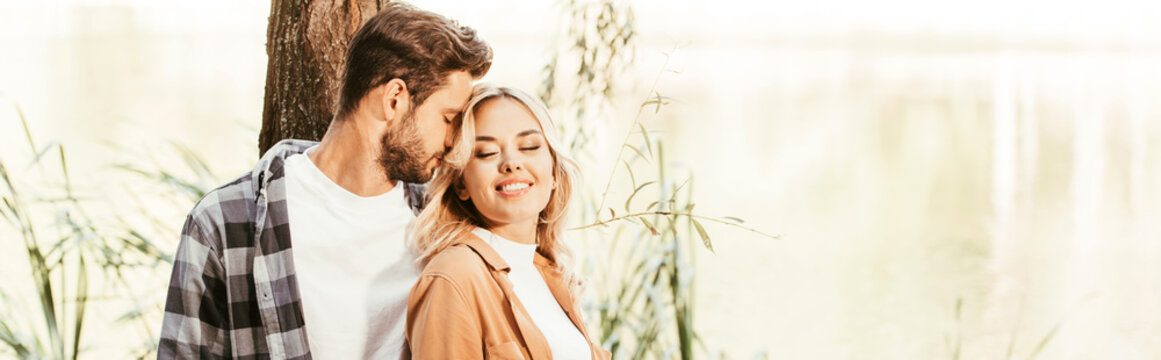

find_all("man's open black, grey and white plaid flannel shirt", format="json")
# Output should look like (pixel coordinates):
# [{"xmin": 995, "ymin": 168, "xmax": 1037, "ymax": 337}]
[{"xmin": 157, "ymin": 141, "xmax": 424, "ymax": 359}]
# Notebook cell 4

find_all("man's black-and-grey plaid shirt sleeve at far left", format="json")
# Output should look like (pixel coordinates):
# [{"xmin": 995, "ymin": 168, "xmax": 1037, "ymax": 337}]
[{"xmin": 157, "ymin": 215, "xmax": 230, "ymax": 359}]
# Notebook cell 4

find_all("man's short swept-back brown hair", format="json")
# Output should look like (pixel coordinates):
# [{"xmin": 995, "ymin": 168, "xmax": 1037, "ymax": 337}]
[{"xmin": 336, "ymin": 1, "xmax": 492, "ymax": 118}]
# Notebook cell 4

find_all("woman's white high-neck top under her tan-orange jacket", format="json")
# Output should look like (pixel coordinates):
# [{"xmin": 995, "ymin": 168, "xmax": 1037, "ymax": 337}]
[{"xmin": 471, "ymin": 228, "xmax": 592, "ymax": 360}]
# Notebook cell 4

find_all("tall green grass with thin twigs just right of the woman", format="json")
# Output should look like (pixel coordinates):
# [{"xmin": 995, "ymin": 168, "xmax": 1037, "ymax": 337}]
[{"xmin": 574, "ymin": 80, "xmax": 777, "ymax": 359}]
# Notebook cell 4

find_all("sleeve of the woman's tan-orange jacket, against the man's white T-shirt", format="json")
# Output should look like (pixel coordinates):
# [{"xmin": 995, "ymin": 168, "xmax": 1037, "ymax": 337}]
[{"xmin": 406, "ymin": 275, "xmax": 484, "ymax": 359}]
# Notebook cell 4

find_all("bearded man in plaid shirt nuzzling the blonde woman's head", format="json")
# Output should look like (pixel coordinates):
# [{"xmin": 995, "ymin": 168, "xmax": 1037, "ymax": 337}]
[{"xmin": 158, "ymin": 3, "xmax": 492, "ymax": 359}]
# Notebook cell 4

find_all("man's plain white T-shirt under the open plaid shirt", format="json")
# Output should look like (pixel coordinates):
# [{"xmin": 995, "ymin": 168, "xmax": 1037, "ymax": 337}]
[{"xmin": 286, "ymin": 145, "xmax": 419, "ymax": 359}]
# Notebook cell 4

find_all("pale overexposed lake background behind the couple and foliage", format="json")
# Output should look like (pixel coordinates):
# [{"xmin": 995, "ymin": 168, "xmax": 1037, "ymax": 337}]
[{"xmin": 0, "ymin": 0, "xmax": 1161, "ymax": 359}]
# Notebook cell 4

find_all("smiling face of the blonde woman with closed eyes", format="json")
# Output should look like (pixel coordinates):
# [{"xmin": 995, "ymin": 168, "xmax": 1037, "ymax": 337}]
[{"xmin": 456, "ymin": 98, "xmax": 555, "ymax": 228}]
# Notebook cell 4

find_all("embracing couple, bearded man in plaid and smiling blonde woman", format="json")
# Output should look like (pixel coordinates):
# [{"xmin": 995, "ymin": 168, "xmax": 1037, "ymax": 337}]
[{"xmin": 158, "ymin": 2, "xmax": 608, "ymax": 359}]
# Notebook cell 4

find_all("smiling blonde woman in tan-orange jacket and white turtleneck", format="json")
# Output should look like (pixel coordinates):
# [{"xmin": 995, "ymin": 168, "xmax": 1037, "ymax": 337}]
[{"xmin": 406, "ymin": 85, "xmax": 608, "ymax": 359}]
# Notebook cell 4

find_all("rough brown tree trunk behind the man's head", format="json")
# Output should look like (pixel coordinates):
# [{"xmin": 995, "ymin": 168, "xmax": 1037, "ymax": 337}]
[{"xmin": 258, "ymin": 0, "xmax": 389, "ymax": 156}]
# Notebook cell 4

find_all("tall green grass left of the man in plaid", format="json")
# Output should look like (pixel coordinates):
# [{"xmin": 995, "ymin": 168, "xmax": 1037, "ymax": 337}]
[{"xmin": 0, "ymin": 99, "xmax": 213, "ymax": 359}]
